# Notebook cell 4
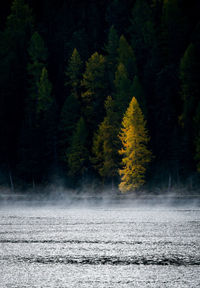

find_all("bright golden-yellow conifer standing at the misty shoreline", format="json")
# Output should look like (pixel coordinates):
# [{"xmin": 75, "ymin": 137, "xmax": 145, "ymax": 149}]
[{"xmin": 119, "ymin": 97, "xmax": 152, "ymax": 192}]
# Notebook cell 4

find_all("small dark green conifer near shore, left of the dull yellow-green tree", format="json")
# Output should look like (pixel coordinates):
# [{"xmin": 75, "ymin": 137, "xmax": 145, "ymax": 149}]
[{"xmin": 68, "ymin": 117, "xmax": 89, "ymax": 178}]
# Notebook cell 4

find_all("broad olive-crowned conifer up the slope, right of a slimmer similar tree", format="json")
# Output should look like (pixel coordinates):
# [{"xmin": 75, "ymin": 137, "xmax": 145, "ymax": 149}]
[{"xmin": 82, "ymin": 52, "xmax": 107, "ymax": 130}]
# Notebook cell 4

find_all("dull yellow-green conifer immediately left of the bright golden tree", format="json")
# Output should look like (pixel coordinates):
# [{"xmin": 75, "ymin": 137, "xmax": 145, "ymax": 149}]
[{"xmin": 92, "ymin": 96, "xmax": 119, "ymax": 181}]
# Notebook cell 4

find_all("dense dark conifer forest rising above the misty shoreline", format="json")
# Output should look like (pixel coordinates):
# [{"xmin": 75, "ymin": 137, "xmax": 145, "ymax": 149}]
[{"xmin": 0, "ymin": 0, "xmax": 200, "ymax": 191}]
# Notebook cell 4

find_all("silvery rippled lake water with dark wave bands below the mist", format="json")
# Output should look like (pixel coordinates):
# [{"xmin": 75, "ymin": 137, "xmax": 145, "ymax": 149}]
[{"xmin": 0, "ymin": 207, "xmax": 200, "ymax": 288}]
